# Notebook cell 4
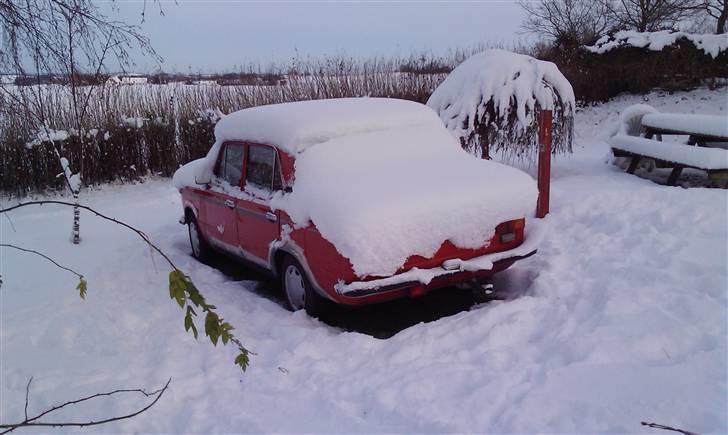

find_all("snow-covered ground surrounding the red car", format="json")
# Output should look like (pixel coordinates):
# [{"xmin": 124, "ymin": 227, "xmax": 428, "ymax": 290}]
[{"xmin": 0, "ymin": 89, "xmax": 728, "ymax": 433}]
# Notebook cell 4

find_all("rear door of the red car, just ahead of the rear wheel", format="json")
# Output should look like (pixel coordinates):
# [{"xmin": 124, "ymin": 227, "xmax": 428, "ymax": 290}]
[{"xmin": 237, "ymin": 144, "xmax": 282, "ymax": 265}]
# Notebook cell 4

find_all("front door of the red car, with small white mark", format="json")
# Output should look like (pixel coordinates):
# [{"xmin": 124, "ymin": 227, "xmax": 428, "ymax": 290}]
[{"xmin": 204, "ymin": 143, "xmax": 245, "ymax": 253}]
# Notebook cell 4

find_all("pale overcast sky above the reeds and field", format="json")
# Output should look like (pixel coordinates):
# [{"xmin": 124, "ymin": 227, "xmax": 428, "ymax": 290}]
[{"xmin": 103, "ymin": 0, "xmax": 523, "ymax": 72}]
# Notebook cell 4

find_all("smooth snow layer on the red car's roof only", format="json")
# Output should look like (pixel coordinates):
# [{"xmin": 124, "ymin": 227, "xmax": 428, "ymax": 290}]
[{"xmin": 215, "ymin": 98, "xmax": 441, "ymax": 155}]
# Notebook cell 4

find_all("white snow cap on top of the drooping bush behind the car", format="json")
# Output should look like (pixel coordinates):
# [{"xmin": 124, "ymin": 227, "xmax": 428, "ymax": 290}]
[{"xmin": 427, "ymin": 50, "xmax": 575, "ymax": 137}]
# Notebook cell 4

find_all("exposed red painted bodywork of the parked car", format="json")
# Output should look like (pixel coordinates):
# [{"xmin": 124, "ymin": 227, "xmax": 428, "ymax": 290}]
[{"xmin": 181, "ymin": 141, "xmax": 535, "ymax": 305}]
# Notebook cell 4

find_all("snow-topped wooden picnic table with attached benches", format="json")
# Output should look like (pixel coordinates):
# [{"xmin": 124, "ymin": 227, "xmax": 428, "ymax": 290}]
[{"xmin": 608, "ymin": 113, "xmax": 728, "ymax": 187}]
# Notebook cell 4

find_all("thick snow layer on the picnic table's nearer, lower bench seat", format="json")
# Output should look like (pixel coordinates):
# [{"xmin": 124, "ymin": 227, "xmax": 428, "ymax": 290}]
[{"xmin": 609, "ymin": 135, "xmax": 728, "ymax": 170}]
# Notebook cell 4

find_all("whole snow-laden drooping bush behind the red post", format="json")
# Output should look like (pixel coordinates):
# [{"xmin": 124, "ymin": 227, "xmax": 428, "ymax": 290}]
[{"xmin": 427, "ymin": 50, "xmax": 576, "ymax": 162}]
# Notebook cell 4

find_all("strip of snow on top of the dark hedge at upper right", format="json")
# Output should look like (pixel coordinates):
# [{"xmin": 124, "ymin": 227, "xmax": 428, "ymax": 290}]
[{"xmin": 585, "ymin": 30, "xmax": 728, "ymax": 59}]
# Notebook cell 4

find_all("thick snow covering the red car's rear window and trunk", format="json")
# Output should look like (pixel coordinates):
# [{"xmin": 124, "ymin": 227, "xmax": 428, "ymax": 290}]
[{"xmin": 272, "ymin": 123, "xmax": 537, "ymax": 278}]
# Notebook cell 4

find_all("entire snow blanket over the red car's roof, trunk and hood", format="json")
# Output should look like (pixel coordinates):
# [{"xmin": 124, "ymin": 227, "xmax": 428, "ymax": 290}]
[{"xmin": 173, "ymin": 98, "xmax": 537, "ymax": 277}]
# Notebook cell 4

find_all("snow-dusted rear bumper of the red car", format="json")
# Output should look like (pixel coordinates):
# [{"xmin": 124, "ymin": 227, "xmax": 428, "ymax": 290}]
[{"xmin": 334, "ymin": 221, "xmax": 544, "ymax": 297}]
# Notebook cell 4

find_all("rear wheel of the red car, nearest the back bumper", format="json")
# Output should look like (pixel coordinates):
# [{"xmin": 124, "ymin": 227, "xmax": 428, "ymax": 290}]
[{"xmin": 278, "ymin": 255, "xmax": 330, "ymax": 318}]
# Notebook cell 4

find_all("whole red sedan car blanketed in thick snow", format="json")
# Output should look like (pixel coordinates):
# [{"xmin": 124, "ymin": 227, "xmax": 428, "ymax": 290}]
[{"xmin": 174, "ymin": 98, "xmax": 537, "ymax": 316}]
